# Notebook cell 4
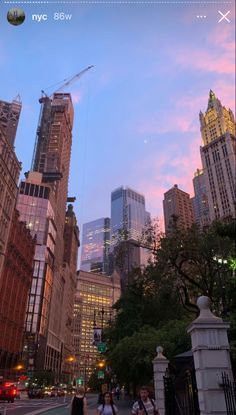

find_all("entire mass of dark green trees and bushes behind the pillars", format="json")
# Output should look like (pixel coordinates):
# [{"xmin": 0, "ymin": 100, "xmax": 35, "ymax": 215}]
[{"xmin": 106, "ymin": 218, "xmax": 236, "ymax": 385}]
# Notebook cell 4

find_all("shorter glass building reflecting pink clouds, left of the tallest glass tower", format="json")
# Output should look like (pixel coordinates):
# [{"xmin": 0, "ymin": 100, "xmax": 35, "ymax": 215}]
[{"xmin": 80, "ymin": 218, "xmax": 111, "ymax": 275}]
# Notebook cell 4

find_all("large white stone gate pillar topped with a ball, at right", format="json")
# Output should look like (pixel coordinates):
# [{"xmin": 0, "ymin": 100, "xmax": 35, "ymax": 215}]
[{"xmin": 188, "ymin": 296, "xmax": 233, "ymax": 415}]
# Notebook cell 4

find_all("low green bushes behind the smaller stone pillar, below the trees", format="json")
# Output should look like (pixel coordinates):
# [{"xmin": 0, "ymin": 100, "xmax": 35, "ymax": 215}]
[{"xmin": 108, "ymin": 320, "xmax": 190, "ymax": 386}]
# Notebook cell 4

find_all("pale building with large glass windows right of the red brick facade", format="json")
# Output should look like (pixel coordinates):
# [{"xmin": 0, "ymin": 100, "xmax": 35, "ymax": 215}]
[{"xmin": 17, "ymin": 172, "xmax": 57, "ymax": 374}]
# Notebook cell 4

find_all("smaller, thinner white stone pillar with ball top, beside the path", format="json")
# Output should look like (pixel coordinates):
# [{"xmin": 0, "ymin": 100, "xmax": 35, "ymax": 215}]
[{"xmin": 152, "ymin": 346, "xmax": 169, "ymax": 415}]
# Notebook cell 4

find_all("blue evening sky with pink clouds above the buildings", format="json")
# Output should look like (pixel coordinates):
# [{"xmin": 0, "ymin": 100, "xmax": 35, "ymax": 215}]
[{"xmin": 0, "ymin": 1, "xmax": 235, "ymax": 237}]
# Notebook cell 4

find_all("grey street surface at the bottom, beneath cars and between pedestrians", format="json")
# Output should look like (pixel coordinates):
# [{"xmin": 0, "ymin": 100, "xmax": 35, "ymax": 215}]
[{"xmin": 0, "ymin": 394, "xmax": 132, "ymax": 415}]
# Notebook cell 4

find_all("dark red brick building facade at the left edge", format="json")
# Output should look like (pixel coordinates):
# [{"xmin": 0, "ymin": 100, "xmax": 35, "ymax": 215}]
[{"xmin": 0, "ymin": 209, "xmax": 35, "ymax": 379}]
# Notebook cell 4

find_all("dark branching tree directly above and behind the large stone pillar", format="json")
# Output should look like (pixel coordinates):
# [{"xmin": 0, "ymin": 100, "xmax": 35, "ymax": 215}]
[{"xmin": 156, "ymin": 223, "xmax": 235, "ymax": 316}]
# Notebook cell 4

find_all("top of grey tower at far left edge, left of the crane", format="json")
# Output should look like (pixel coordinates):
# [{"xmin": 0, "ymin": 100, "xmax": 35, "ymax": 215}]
[{"xmin": 0, "ymin": 96, "xmax": 22, "ymax": 147}]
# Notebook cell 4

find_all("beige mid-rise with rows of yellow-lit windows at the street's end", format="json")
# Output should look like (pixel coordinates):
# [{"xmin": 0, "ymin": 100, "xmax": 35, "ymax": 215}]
[{"xmin": 73, "ymin": 271, "xmax": 120, "ymax": 385}]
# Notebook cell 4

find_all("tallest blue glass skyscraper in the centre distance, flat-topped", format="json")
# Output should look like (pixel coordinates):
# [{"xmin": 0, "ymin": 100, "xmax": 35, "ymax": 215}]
[{"xmin": 110, "ymin": 186, "xmax": 151, "ymax": 291}]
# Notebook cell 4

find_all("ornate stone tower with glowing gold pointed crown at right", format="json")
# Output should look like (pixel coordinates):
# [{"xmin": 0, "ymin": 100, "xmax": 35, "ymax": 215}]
[{"xmin": 199, "ymin": 91, "xmax": 236, "ymax": 221}]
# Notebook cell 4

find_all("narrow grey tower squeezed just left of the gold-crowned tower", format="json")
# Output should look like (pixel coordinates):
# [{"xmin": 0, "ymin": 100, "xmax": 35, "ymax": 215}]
[{"xmin": 192, "ymin": 169, "xmax": 210, "ymax": 228}]
